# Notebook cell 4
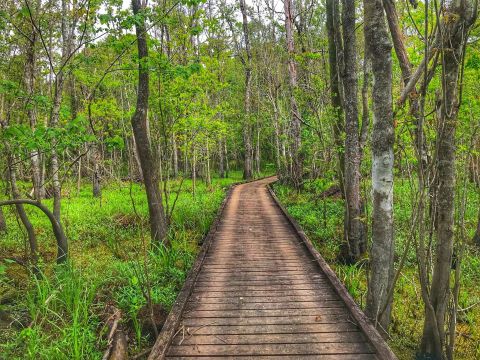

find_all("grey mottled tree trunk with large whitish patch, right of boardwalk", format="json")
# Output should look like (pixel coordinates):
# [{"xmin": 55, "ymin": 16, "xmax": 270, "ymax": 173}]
[{"xmin": 364, "ymin": 0, "xmax": 395, "ymax": 335}]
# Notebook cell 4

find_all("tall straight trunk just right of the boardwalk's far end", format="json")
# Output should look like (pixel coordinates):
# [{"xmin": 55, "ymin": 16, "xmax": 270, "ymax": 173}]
[{"xmin": 284, "ymin": 0, "xmax": 303, "ymax": 189}]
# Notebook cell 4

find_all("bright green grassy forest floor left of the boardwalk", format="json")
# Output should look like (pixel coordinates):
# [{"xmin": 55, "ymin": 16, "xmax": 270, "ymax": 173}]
[{"xmin": 0, "ymin": 172, "xmax": 274, "ymax": 359}]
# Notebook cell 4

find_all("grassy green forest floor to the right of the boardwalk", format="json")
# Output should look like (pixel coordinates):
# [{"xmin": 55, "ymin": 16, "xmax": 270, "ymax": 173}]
[{"xmin": 274, "ymin": 180, "xmax": 480, "ymax": 360}]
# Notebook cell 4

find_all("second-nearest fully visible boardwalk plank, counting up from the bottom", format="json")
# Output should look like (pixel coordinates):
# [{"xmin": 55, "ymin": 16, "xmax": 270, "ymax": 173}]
[{"xmin": 172, "ymin": 331, "xmax": 366, "ymax": 345}]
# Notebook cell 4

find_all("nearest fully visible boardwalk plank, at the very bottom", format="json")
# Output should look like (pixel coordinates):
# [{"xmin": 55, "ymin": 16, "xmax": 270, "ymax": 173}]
[{"xmin": 168, "ymin": 342, "xmax": 374, "ymax": 356}]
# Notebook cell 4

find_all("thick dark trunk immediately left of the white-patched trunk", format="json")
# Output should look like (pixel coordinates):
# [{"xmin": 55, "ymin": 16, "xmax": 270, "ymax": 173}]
[{"xmin": 341, "ymin": 0, "xmax": 366, "ymax": 262}]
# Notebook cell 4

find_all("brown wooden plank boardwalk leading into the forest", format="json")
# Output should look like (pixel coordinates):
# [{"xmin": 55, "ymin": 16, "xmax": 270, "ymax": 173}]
[{"xmin": 149, "ymin": 178, "xmax": 395, "ymax": 360}]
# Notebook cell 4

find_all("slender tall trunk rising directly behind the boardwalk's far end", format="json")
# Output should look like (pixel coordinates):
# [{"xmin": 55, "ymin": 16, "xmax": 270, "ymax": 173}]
[{"xmin": 240, "ymin": 0, "xmax": 253, "ymax": 180}]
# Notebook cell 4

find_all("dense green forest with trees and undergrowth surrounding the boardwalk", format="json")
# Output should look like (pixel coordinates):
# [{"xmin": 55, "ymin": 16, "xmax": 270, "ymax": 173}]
[{"xmin": 0, "ymin": 0, "xmax": 480, "ymax": 359}]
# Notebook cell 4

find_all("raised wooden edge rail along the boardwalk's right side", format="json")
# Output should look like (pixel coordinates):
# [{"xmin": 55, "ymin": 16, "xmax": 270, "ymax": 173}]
[{"xmin": 267, "ymin": 184, "xmax": 398, "ymax": 360}]
